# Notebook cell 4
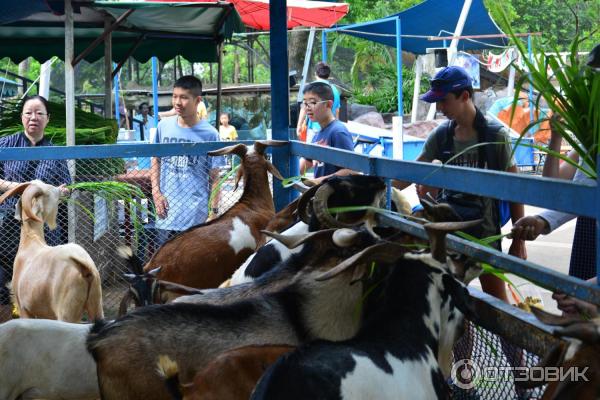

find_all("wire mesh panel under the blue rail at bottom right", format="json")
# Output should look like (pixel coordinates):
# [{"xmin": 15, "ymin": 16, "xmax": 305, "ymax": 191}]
[{"xmin": 449, "ymin": 322, "xmax": 545, "ymax": 400}]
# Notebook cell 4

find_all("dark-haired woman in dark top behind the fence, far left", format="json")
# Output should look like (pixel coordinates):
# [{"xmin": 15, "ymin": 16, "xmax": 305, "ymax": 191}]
[{"xmin": 0, "ymin": 96, "xmax": 71, "ymax": 322}]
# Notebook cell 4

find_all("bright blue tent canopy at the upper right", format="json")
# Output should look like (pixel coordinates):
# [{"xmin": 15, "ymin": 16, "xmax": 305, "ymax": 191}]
[{"xmin": 334, "ymin": 0, "xmax": 508, "ymax": 54}]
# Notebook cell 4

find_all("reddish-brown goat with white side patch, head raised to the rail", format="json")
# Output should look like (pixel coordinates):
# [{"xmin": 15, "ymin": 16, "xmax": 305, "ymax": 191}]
[{"xmin": 144, "ymin": 140, "xmax": 286, "ymax": 289}]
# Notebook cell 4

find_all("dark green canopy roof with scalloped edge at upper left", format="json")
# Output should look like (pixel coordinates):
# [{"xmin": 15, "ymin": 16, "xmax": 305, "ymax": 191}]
[{"xmin": 0, "ymin": 0, "xmax": 244, "ymax": 63}]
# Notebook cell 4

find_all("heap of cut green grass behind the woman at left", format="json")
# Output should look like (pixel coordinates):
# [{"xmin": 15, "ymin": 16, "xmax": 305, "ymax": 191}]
[{"xmin": 0, "ymin": 101, "xmax": 119, "ymax": 146}]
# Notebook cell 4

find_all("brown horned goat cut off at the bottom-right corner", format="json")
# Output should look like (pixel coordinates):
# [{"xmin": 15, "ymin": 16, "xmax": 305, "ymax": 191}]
[{"xmin": 515, "ymin": 307, "xmax": 600, "ymax": 400}]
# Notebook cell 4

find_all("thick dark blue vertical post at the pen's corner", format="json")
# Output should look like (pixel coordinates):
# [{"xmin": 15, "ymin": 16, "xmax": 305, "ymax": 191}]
[{"xmin": 269, "ymin": 0, "xmax": 291, "ymax": 210}]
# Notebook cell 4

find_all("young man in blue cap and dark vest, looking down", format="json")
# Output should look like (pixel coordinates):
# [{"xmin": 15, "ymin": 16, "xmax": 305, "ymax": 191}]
[{"xmin": 395, "ymin": 66, "xmax": 527, "ymax": 302}]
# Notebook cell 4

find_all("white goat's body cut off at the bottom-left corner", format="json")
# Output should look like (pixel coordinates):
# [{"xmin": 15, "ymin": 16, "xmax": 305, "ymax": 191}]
[{"xmin": 0, "ymin": 319, "xmax": 100, "ymax": 400}]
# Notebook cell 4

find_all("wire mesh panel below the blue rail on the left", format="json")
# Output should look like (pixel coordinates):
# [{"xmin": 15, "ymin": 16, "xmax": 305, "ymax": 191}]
[{"xmin": 0, "ymin": 156, "xmax": 253, "ymax": 318}]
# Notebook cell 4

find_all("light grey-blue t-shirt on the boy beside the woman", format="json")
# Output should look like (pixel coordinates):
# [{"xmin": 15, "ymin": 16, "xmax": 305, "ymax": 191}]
[{"xmin": 154, "ymin": 116, "xmax": 224, "ymax": 231}]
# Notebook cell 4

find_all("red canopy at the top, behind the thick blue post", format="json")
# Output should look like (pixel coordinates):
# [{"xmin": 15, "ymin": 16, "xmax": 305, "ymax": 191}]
[{"xmin": 231, "ymin": 0, "xmax": 348, "ymax": 30}]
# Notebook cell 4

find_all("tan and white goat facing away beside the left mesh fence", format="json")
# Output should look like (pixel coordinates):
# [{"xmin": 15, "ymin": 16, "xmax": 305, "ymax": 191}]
[{"xmin": 0, "ymin": 181, "xmax": 104, "ymax": 322}]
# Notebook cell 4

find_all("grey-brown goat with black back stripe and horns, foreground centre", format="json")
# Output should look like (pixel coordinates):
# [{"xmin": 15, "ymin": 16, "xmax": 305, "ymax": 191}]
[{"xmin": 88, "ymin": 228, "xmax": 390, "ymax": 400}]
